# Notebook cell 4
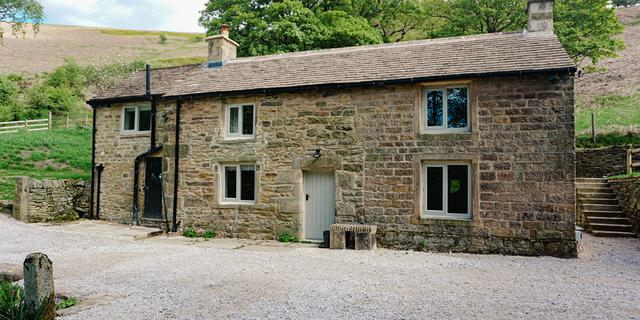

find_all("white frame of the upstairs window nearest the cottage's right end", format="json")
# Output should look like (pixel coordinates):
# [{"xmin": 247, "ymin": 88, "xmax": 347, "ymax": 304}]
[{"xmin": 422, "ymin": 85, "xmax": 471, "ymax": 133}]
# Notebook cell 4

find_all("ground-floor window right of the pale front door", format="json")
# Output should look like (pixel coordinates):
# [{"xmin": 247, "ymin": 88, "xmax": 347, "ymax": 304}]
[{"xmin": 422, "ymin": 163, "xmax": 471, "ymax": 219}]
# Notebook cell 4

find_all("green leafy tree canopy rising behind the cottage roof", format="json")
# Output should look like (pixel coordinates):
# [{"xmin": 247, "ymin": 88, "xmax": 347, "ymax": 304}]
[{"xmin": 200, "ymin": 0, "xmax": 624, "ymax": 64}]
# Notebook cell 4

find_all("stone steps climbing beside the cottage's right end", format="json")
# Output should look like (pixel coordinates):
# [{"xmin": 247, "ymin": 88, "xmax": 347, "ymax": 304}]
[{"xmin": 576, "ymin": 178, "xmax": 635, "ymax": 237}]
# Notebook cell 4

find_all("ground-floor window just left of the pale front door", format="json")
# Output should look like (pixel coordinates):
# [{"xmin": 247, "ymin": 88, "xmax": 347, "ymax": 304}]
[{"xmin": 222, "ymin": 164, "xmax": 256, "ymax": 203}]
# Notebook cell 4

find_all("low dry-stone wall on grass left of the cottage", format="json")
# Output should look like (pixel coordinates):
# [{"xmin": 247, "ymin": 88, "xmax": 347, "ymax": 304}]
[{"xmin": 13, "ymin": 177, "xmax": 90, "ymax": 222}]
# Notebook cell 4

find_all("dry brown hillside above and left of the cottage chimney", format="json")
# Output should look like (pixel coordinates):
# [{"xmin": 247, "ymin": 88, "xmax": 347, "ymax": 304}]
[{"xmin": 0, "ymin": 25, "xmax": 207, "ymax": 75}]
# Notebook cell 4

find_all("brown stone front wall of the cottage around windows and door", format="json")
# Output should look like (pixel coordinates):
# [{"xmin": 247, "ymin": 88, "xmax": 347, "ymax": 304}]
[{"xmin": 142, "ymin": 75, "xmax": 576, "ymax": 257}]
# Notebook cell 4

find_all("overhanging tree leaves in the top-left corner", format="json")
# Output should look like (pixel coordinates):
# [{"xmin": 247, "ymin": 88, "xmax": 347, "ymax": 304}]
[{"xmin": 0, "ymin": 0, "xmax": 44, "ymax": 44}]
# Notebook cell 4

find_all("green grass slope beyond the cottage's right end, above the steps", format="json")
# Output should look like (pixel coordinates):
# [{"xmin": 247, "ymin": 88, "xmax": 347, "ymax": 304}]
[{"xmin": 576, "ymin": 92, "xmax": 640, "ymax": 134}]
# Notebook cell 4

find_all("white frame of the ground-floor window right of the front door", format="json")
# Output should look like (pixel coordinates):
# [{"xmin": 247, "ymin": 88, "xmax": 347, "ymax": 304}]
[{"xmin": 420, "ymin": 162, "xmax": 473, "ymax": 220}]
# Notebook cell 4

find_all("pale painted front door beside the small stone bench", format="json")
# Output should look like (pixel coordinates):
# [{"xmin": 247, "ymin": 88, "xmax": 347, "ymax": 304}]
[{"xmin": 304, "ymin": 171, "xmax": 335, "ymax": 240}]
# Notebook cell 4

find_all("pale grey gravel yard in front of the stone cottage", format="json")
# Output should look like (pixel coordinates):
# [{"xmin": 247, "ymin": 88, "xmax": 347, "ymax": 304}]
[{"xmin": 0, "ymin": 215, "xmax": 640, "ymax": 320}]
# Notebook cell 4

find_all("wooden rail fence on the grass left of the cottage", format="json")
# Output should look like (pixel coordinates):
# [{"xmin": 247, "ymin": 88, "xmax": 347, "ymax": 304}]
[{"xmin": 0, "ymin": 112, "xmax": 92, "ymax": 134}]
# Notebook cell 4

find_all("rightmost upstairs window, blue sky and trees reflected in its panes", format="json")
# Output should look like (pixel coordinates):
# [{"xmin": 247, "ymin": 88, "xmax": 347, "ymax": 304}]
[{"xmin": 423, "ymin": 87, "xmax": 471, "ymax": 132}]
